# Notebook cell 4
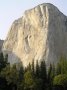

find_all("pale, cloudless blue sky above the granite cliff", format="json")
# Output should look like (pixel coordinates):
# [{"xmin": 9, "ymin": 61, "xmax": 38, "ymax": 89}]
[{"xmin": 0, "ymin": 0, "xmax": 67, "ymax": 39}]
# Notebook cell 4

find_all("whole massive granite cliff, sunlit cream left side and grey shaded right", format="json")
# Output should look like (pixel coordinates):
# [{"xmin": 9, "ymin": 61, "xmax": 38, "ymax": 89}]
[{"xmin": 3, "ymin": 3, "xmax": 67, "ymax": 66}]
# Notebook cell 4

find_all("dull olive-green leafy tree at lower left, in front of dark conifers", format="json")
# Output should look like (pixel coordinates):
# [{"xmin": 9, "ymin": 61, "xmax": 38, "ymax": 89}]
[{"xmin": 1, "ymin": 65, "xmax": 19, "ymax": 84}]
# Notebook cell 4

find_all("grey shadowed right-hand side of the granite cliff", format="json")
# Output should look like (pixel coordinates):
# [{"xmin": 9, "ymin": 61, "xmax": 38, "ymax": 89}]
[{"xmin": 46, "ymin": 8, "xmax": 67, "ymax": 65}]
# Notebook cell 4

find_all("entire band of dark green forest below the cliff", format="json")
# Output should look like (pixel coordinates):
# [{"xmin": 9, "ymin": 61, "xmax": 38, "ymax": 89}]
[{"xmin": 0, "ymin": 53, "xmax": 67, "ymax": 90}]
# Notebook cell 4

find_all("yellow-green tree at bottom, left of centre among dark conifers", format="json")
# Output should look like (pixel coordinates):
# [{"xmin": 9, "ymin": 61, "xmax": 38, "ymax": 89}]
[{"xmin": 24, "ymin": 70, "xmax": 36, "ymax": 90}]
